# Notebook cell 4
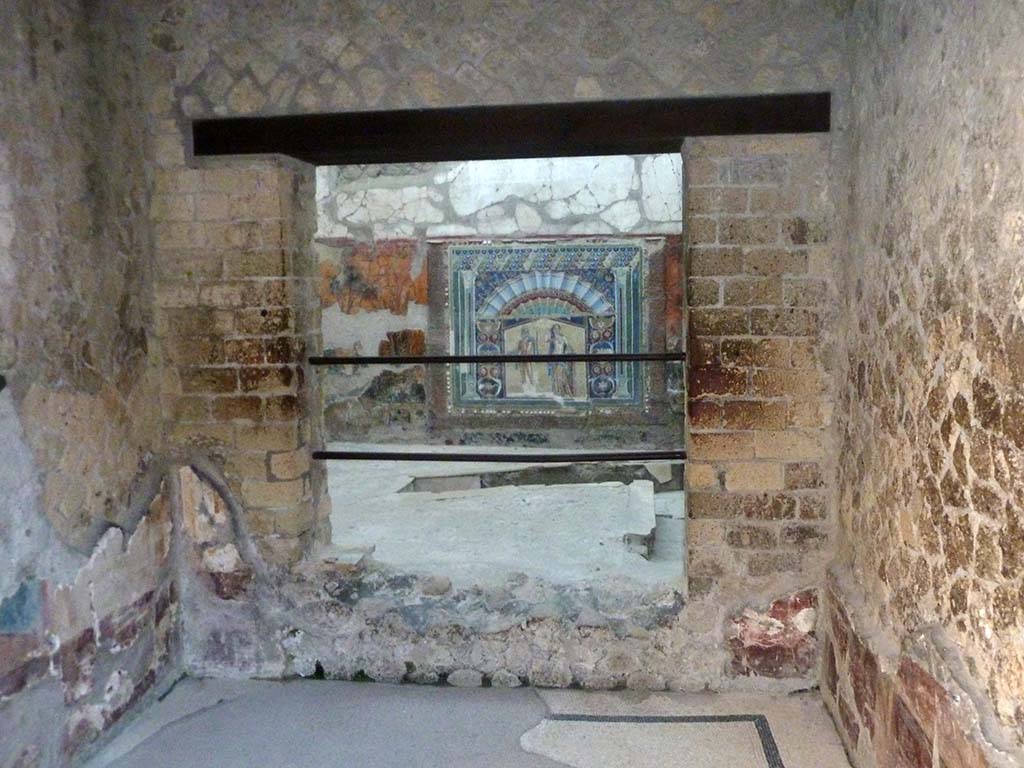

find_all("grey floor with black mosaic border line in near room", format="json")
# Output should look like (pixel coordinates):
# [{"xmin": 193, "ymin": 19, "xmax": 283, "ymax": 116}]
[{"xmin": 87, "ymin": 680, "xmax": 849, "ymax": 768}]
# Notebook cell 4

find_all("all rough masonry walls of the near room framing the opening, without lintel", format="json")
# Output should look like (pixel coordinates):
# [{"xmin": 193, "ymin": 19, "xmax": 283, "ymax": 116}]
[{"xmin": 0, "ymin": 0, "xmax": 1024, "ymax": 768}]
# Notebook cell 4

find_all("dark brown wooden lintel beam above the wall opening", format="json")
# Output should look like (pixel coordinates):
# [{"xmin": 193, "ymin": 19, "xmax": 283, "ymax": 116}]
[{"xmin": 193, "ymin": 92, "xmax": 831, "ymax": 165}]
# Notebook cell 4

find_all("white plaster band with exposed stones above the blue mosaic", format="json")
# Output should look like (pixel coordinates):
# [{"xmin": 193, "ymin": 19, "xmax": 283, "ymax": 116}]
[{"xmin": 316, "ymin": 154, "xmax": 683, "ymax": 240}]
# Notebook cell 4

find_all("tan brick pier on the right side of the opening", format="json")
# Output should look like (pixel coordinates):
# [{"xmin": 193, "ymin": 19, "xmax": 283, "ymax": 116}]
[{"xmin": 684, "ymin": 136, "xmax": 833, "ymax": 594}]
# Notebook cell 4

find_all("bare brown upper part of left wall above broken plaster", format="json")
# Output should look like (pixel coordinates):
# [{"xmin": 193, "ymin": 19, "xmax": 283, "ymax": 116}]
[{"xmin": 0, "ymin": 2, "xmax": 158, "ymax": 565}]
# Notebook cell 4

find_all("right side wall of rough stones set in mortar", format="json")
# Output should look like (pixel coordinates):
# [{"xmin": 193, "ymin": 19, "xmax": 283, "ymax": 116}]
[{"xmin": 826, "ymin": 1, "xmax": 1024, "ymax": 766}]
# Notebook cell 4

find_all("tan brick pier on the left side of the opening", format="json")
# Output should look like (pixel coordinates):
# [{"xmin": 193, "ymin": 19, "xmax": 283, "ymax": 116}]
[{"xmin": 153, "ymin": 153, "xmax": 328, "ymax": 563}]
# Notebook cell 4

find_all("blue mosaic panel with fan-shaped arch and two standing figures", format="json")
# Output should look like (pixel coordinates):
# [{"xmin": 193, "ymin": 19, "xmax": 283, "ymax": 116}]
[{"xmin": 449, "ymin": 242, "xmax": 647, "ymax": 411}]
